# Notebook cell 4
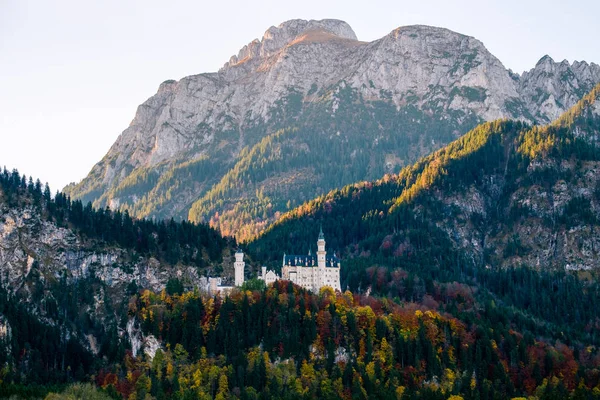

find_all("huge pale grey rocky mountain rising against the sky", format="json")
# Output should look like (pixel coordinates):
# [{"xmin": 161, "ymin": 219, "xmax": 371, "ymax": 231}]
[{"xmin": 64, "ymin": 20, "xmax": 600, "ymax": 239}]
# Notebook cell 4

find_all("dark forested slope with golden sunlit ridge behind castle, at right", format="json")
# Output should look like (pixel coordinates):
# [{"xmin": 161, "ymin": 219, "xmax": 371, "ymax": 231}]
[{"xmin": 241, "ymin": 85, "xmax": 600, "ymax": 360}]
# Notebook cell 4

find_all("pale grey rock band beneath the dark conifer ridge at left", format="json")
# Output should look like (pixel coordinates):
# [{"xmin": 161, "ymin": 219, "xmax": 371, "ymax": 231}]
[{"xmin": 0, "ymin": 205, "xmax": 206, "ymax": 293}]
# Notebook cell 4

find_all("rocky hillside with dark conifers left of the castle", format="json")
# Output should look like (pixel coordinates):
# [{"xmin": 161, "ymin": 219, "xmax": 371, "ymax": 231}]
[{"xmin": 0, "ymin": 169, "xmax": 234, "ymax": 390}]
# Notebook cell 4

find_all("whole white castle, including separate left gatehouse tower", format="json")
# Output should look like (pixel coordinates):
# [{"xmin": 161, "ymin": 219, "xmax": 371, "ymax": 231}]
[{"xmin": 208, "ymin": 229, "xmax": 342, "ymax": 293}]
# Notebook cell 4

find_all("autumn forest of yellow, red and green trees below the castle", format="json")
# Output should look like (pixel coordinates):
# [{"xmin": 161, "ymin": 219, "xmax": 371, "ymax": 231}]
[{"xmin": 12, "ymin": 281, "xmax": 600, "ymax": 400}]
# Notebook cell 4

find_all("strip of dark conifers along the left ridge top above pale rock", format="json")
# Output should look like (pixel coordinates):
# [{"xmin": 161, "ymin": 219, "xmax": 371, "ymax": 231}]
[{"xmin": 0, "ymin": 168, "xmax": 230, "ymax": 268}]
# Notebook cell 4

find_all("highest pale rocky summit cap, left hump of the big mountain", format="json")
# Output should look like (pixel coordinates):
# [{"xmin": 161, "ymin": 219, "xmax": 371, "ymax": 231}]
[{"xmin": 223, "ymin": 19, "xmax": 358, "ymax": 69}]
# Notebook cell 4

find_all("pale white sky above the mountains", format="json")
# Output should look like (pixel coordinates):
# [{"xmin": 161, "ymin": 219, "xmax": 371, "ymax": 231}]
[{"xmin": 0, "ymin": 0, "xmax": 600, "ymax": 191}]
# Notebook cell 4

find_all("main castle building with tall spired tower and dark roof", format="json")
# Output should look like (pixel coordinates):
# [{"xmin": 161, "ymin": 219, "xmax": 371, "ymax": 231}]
[{"xmin": 258, "ymin": 229, "xmax": 342, "ymax": 292}]
